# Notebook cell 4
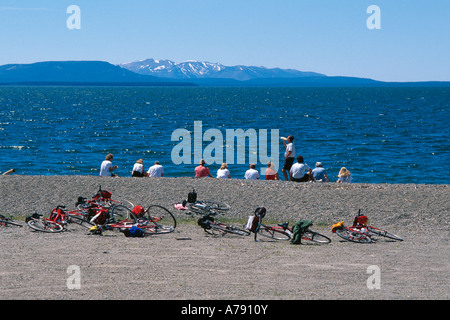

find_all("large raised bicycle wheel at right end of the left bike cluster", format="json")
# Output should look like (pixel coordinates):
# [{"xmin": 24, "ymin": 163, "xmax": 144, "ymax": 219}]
[{"xmin": 141, "ymin": 204, "xmax": 177, "ymax": 234}]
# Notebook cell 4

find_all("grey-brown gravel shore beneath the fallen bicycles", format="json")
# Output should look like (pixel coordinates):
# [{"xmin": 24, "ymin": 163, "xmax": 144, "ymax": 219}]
[{"xmin": 0, "ymin": 175, "xmax": 450, "ymax": 300}]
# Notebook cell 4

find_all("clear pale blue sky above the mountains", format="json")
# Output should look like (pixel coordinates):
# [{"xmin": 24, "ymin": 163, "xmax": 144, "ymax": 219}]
[{"xmin": 0, "ymin": 0, "xmax": 450, "ymax": 81}]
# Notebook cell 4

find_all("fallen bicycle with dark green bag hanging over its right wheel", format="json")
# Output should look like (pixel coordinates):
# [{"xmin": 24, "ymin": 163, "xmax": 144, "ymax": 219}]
[{"xmin": 247, "ymin": 207, "xmax": 331, "ymax": 244}]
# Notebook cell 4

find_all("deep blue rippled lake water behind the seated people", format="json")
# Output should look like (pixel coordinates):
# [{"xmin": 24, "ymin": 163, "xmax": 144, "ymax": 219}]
[{"xmin": 0, "ymin": 87, "xmax": 450, "ymax": 184}]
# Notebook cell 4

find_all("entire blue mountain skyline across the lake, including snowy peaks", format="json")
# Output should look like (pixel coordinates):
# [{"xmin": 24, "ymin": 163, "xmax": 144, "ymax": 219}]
[{"xmin": 0, "ymin": 59, "xmax": 450, "ymax": 87}]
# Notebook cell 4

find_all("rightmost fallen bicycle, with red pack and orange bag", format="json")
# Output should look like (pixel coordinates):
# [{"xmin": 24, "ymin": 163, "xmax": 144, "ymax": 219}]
[{"xmin": 331, "ymin": 209, "xmax": 403, "ymax": 243}]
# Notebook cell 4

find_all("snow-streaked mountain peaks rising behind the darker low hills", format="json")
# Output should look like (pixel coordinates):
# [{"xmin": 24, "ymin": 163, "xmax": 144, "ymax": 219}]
[{"xmin": 119, "ymin": 59, "xmax": 325, "ymax": 81}]
